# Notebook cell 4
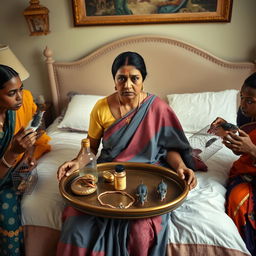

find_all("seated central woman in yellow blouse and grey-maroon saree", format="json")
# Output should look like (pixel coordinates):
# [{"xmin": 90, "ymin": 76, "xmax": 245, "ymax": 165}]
[{"xmin": 57, "ymin": 52, "xmax": 197, "ymax": 256}]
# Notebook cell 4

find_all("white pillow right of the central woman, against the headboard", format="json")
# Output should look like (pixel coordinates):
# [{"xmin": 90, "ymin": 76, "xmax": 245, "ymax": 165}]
[{"xmin": 167, "ymin": 90, "xmax": 239, "ymax": 133}]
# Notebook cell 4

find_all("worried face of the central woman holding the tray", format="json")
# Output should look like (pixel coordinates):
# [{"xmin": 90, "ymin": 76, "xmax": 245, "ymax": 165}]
[{"xmin": 115, "ymin": 66, "xmax": 143, "ymax": 98}]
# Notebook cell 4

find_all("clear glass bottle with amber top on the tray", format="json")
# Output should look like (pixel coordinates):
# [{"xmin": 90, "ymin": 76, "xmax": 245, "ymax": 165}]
[{"xmin": 79, "ymin": 138, "xmax": 98, "ymax": 183}]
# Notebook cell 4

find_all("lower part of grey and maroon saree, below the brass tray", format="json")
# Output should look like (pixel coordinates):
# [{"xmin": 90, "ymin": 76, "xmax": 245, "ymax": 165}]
[{"xmin": 57, "ymin": 206, "xmax": 169, "ymax": 256}]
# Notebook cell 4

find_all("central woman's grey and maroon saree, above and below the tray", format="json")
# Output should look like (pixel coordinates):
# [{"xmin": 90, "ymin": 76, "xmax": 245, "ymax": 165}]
[{"xmin": 57, "ymin": 95, "xmax": 193, "ymax": 256}]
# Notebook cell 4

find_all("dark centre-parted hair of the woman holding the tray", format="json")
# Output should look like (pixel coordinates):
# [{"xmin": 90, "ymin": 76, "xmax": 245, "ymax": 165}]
[{"xmin": 112, "ymin": 52, "xmax": 147, "ymax": 81}]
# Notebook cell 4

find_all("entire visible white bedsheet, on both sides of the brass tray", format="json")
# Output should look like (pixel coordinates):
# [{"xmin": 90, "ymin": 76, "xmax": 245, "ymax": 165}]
[{"xmin": 22, "ymin": 120, "xmax": 250, "ymax": 255}]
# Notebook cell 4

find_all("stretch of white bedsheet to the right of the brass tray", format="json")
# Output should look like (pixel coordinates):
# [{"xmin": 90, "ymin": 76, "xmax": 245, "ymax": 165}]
[{"xmin": 169, "ymin": 148, "xmax": 250, "ymax": 255}]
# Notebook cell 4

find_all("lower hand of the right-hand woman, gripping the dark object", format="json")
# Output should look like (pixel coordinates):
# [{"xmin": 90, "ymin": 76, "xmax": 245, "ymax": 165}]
[{"xmin": 223, "ymin": 129, "xmax": 256, "ymax": 157}]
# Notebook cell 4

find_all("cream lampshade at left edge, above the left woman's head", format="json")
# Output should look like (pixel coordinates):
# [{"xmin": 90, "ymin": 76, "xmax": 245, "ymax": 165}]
[{"xmin": 0, "ymin": 44, "xmax": 29, "ymax": 81}]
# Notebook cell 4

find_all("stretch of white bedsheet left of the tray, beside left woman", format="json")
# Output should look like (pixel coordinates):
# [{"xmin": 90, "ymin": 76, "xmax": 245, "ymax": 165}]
[{"xmin": 21, "ymin": 119, "xmax": 87, "ymax": 230}]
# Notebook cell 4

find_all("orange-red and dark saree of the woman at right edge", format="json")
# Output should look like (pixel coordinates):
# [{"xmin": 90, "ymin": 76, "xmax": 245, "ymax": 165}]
[{"xmin": 226, "ymin": 123, "xmax": 256, "ymax": 255}]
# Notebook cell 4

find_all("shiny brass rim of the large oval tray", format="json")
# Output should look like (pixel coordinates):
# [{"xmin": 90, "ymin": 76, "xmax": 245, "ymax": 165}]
[{"xmin": 59, "ymin": 162, "xmax": 189, "ymax": 219}]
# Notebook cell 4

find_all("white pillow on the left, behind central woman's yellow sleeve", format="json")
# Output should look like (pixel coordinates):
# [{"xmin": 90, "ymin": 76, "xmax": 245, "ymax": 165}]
[{"xmin": 58, "ymin": 94, "xmax": 104, "ymax": 132}]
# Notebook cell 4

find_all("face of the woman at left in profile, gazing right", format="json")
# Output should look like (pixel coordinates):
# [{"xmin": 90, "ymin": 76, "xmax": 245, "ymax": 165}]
[{"xmin": 0, "ymin": 77, "xmax": 23, "ymax": 110}]
